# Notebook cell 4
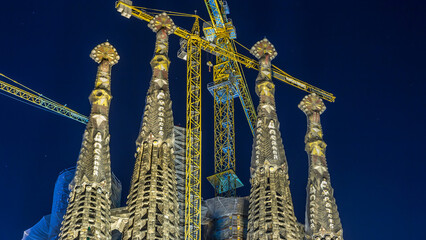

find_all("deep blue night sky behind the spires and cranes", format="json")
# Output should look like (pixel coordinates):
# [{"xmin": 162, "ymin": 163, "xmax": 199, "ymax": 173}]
[{"xmin": 0, "ymin": 0, "xmax": 426, "ymax": 240}]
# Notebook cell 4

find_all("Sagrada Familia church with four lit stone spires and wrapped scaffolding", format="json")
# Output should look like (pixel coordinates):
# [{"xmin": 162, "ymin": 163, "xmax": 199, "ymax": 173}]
[{"xmin": 23, "ymin": 14, "xmax": 343, "ymax": 240}]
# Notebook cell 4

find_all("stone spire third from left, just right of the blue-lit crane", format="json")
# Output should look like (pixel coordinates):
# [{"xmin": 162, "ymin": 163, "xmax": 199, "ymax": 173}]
[{"xmin": 247, "ymin": 39, "xmax": 302, "ymax": 240}]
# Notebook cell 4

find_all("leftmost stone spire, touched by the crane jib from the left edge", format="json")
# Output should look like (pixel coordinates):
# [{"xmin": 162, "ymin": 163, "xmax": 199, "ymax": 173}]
[{"xmin": 59, "ymin": 42, "xmax": 119, "ymax": 240}]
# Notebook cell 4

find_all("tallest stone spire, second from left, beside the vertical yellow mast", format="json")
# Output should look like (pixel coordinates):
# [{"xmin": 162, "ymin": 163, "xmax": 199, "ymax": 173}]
[{"xmin": 123, "ymin": 13, "xmax": 179, "ymax": 240}]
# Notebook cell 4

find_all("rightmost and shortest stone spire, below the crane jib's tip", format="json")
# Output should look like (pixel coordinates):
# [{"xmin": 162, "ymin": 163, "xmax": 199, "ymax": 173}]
[{"xmin": 299, "ymin": 93, "xmax": 343, "ymax": 240}]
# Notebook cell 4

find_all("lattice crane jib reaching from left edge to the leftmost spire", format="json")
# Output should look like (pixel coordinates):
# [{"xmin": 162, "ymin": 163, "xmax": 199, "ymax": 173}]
[{"xmin": 0, "ymin": 73, "xmax": 89, "ymax": 124}]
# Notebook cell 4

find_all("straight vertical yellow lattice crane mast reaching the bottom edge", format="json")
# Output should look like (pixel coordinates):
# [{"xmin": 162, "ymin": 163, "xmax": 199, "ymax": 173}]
[{"xmin": 185, "ymin": 18, "xmax": 201, "ymax": 240}]
